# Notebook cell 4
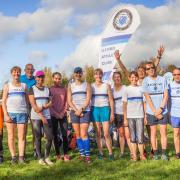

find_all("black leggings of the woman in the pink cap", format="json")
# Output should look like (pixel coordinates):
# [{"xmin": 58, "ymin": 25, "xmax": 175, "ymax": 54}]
[{"xmin": 32, "ymin": 119, "xmax": 53, "ymax": 159}]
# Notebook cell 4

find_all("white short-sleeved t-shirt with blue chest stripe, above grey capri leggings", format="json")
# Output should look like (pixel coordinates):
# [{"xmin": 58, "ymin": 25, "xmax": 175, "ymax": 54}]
[{"xmin": 123, "ymin": 85, "xmax": 144, "ymax": 118}]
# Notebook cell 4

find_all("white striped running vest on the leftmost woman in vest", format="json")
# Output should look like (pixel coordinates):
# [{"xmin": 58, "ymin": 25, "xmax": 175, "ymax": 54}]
[{"xmin": 6, "ymin": 82, "xmax": 27, "ymax": 113}]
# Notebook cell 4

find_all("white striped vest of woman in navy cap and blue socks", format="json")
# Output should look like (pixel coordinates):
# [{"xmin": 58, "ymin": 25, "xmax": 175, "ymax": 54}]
[{"xmin": 70, "ymin": 82, "xmax": 90, "ymax": 111}]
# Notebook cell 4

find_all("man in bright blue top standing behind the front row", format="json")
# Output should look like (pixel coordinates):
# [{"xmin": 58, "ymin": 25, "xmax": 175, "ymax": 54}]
[{"xmin": 20, "ymin": 63, "xmax": 37, "ymax": 158}]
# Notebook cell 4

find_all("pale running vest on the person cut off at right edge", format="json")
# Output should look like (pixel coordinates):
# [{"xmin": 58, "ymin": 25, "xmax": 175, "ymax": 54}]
[{"xmin": 169, "ymin": 81, "xmax": 180, "ymax": 117}]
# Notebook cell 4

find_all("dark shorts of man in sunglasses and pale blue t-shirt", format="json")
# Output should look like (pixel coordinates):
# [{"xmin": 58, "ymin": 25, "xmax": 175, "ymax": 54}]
[{"xmin": 147, "ymin": 113, "xmax": 168, "ymax": 126}]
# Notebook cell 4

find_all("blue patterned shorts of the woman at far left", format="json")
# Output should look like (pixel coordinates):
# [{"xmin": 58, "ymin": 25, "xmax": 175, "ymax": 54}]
[{"xmin": 8, "ymin": 112, "xmax": 28, "ymax": 124}]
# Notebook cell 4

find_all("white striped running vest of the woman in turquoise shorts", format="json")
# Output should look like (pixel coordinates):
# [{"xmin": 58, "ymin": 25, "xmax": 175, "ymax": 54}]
[{"xmin": 91, "ymin": 83, "xmax": 109, "ymax": 107}]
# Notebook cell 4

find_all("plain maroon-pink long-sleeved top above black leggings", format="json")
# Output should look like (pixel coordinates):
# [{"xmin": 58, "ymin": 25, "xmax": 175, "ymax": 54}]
[{"xmin": 50, "ymin": 86, "xmax": 67, "ymax": 119}]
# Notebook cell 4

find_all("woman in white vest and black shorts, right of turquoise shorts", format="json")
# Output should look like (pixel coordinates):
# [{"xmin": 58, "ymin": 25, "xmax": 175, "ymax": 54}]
[{"xmin": 112, "ymin": 71, "xmax": 132, "ymax": 157}]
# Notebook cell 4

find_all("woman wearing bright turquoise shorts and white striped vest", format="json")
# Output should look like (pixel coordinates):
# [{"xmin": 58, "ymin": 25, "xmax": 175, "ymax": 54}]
[{"xmin": 91, "ymin": 69, "xmax": 114, "ymax": 160}]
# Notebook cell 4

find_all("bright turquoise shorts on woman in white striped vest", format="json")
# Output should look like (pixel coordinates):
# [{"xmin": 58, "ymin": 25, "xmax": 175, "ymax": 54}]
[{"xmin": 91, "ymin": 106, "xmax": 110, "ymax": 123}]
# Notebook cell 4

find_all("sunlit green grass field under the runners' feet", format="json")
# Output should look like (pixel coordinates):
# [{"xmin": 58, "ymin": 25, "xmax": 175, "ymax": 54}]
[{"xmin": 0, "ymin": 125, "xmax": 180, "ymax": 180}]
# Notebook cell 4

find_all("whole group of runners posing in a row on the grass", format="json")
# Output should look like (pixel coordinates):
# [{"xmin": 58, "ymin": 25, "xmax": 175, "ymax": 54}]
[{"xmin": 2, "ymin": 46, "xmax": 180, "ymax": 165}]
